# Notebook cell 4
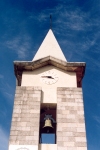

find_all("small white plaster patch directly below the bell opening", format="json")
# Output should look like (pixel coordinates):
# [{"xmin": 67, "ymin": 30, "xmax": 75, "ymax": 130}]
[{"xmin": 39, "ymin": 144, "xmax": 57, "ymax": 150}]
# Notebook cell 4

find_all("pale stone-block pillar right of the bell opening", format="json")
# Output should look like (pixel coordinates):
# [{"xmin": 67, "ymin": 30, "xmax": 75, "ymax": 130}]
[{"xmin": 57, "ymin": 87, "xmax": 87, "ymax": 150}]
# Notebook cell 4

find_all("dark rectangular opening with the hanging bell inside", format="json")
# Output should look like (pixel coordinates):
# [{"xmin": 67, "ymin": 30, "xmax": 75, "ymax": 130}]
[{"xmin": 39, "ymin": 103, "xmax": 56, "ymax": 144}]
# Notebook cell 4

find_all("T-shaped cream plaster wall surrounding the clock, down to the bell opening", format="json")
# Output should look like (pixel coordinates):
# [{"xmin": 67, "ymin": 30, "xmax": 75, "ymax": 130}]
[{"xmin": 21, "ymin": 65, "xmax": 77, "ymax": 103}]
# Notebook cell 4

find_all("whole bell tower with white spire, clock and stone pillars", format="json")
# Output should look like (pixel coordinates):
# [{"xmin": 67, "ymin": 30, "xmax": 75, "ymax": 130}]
[{"xmin": 9, "ymin": 29, "xmax": 87, "ymax": 150}]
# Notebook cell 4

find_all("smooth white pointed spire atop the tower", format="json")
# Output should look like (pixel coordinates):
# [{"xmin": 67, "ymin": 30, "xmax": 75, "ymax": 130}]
[{"xmin": 32, "ymin": 29, "xmax": 67, "ymax": 61}]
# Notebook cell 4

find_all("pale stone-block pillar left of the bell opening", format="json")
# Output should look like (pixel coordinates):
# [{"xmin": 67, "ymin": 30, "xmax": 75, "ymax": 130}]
[{"xmin": 9, "ymin": 86, "xmax": 41, "ymax": 145}]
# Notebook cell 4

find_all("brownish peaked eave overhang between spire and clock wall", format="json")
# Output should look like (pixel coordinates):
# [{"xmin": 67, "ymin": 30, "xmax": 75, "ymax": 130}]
[{"xmin": 14, "ymin": 56, "xmax": 86, "ymax": 87}]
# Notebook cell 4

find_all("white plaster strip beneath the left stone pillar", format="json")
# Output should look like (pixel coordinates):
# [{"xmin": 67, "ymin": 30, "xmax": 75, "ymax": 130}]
[{"xmin": 9, "ymin": 145, "xmax": 38, "ymax": 150}]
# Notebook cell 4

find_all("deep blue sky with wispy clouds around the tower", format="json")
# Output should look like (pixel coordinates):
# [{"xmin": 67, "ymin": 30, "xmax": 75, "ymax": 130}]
[{"xmin": 0, "ymin": 0, "xmax": 100, "ymax": 150}]
